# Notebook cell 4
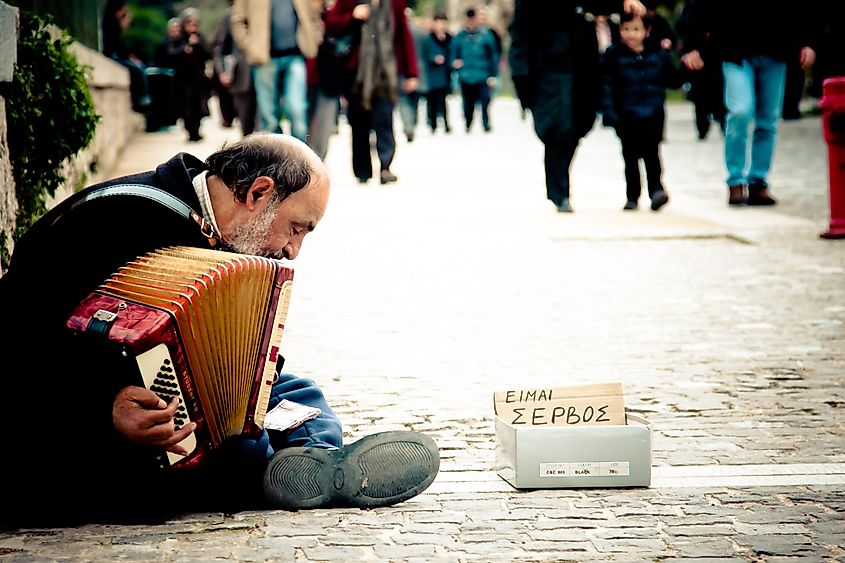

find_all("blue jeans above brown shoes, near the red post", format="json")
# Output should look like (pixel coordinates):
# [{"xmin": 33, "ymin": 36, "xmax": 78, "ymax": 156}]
[{"xmin": 722, "ymin": 57, "xmax": 786, "ymax": 186}]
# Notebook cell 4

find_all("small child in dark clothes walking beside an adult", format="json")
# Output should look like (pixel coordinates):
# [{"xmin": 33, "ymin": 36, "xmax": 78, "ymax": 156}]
[{"xmin": 602, "ymin": 14, "xmax": 682, "ymax": 211}]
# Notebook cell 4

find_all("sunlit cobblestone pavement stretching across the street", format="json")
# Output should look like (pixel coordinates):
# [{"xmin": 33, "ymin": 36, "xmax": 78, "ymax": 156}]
[{"xmin": 0, "ymin": 100, "xmax": 845, "ymax": 561}]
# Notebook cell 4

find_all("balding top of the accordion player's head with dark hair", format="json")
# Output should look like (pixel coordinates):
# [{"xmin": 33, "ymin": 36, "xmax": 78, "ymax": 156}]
[{"xmin": 205, "ymin": 133, "xmax": 328, "ymax": 203}]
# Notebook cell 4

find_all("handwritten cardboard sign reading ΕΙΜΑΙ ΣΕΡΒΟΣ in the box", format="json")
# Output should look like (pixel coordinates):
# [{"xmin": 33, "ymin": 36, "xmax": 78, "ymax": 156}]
[{"xmin": 493, "ymin": 383, "xmax": 625, "ymax": 426}]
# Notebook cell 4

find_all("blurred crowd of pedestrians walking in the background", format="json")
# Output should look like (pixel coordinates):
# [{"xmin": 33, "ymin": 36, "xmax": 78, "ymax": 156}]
[{"xmin": 102, "ymin": 0, "xmax": 845, "ymax": 212}]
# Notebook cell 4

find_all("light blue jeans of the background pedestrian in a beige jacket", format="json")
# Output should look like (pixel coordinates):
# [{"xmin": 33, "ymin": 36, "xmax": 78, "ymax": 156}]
[{"xmin": 252, "ymin": 55, "xmax": 308, "ymax": 141}]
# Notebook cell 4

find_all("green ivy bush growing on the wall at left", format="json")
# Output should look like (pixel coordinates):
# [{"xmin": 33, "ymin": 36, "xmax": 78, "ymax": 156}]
[{"xmin": 4, "ymin": 11, "xmax": 100, "ymax": 252}]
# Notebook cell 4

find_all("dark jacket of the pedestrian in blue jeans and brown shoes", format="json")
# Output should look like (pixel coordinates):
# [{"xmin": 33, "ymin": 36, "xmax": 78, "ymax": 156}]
[{"xmin": 679, "ymin": 0, "xmax": 820, "ymax": 63}]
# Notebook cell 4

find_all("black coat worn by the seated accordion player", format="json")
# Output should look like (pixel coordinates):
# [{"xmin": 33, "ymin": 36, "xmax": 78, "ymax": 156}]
[{"xmin": 0, "ymin": 154, "xmax": 214, "ymax": 525}]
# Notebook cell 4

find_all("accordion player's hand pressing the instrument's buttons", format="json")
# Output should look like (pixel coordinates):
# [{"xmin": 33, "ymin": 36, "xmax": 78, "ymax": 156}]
[{"xmin": 112, "ymin": 386, "xmax": 197, "ymax": 455}]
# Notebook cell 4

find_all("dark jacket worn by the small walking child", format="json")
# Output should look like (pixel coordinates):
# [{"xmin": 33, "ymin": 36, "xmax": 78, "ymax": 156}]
[{"xmin": 601, "ymin": 43, "xmax": 682, "ymax": 127}]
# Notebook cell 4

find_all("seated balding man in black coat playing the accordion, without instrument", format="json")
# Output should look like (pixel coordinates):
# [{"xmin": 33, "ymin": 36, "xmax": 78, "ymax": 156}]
[{"xmin": 0, "ymin": 133, "xmax": 439, "ymax": 527}]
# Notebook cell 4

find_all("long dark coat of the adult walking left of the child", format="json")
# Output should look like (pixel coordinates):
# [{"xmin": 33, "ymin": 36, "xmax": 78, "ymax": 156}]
[{"xmin": 509, "ymin": 0, "xmax": 622, "ymax": 143}]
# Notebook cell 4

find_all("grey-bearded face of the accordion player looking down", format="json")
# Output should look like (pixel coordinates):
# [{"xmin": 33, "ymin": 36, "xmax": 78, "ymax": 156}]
[{"xmin": 225, "ymin": 174, "xmax": 329, "ymax": 260}]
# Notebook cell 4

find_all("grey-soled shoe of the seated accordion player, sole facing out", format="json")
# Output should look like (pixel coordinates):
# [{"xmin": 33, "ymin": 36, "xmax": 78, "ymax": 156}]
[{"xmin": 264, "ymin": 431, "xmax": 440, "ymax": 510}]
